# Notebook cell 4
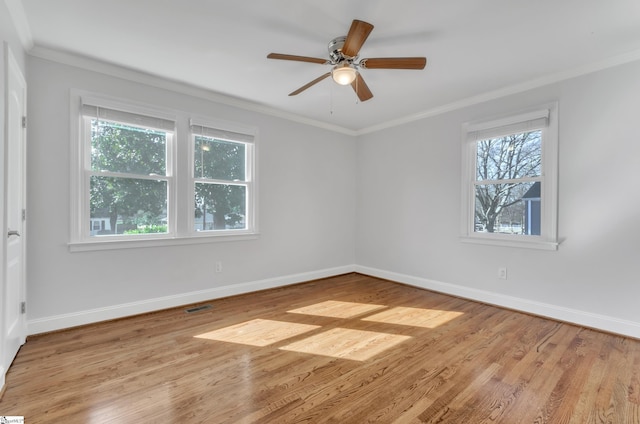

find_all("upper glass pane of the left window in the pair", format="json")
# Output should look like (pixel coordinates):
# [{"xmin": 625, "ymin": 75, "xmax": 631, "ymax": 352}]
[{"xmin": 91, "ymin": 119, "xmax": 167, "ymax": 175}]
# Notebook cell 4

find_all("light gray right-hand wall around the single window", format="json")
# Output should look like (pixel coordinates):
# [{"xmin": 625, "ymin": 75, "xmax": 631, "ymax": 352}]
[{"xmin": 356, "ymin": 62, "xmax": 640, "ymax": 337}]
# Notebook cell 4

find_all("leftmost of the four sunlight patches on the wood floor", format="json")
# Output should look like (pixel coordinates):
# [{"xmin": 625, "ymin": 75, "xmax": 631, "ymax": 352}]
[{"xmin": 195, "ymin": 319, "xmax": 320, "ymax": 347}]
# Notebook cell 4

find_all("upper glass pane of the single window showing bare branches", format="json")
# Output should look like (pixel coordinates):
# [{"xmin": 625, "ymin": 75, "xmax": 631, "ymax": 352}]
[{"xmin": 476, "ymin": 130, "xmax": 542, "ymax": 181}]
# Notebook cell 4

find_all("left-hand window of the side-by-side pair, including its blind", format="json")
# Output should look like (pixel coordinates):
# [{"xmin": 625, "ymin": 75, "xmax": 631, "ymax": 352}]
[{"xmin": 82, "ymin": 104, "xmax": 175, "ymax": 238}]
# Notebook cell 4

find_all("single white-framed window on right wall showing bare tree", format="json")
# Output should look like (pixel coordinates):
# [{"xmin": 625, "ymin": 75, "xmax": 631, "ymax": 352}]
[{"xmin": 462, "ymin": 104, "xmax": 557, "ymax": 249}]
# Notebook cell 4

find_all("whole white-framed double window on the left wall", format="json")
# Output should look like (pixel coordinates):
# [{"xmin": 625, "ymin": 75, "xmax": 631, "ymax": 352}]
[{"xmin": 70, "ymin": 94, "xmax": 256, "ymax": 251}]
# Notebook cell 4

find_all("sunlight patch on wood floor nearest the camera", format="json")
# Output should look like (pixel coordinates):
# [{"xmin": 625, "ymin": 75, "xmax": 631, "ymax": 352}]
[{"xmin": 280, "ymin": 328, "xmax": 411, "ymax": 361}]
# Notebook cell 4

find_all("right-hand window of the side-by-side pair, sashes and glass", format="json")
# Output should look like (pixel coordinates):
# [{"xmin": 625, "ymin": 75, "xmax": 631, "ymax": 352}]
[{"xmin": 192, "ymin": 131, "xmax": 252, "ymax": 233}]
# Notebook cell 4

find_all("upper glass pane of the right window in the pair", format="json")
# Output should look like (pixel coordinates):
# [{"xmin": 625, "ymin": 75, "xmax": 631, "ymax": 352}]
[{"xmin": 193, "ymin": 136, "xmax": 246, "ymax": 181}]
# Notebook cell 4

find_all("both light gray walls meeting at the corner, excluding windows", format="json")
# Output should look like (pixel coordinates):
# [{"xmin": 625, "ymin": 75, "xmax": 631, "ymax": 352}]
[{"xmin": 22, "ymin": 44, "xmax": 640, "ymax": 337}]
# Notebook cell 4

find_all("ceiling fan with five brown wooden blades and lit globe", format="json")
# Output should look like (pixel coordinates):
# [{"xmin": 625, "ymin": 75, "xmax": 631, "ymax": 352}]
[{"xmin": 267, "ymin": 19, "xmax": 427, "ymax": 102}]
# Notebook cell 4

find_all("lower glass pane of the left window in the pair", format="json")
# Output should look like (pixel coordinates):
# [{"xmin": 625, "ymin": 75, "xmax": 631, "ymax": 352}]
[{"xmin": 90, "ymin": 176, "xmax": 168, "ymax": 236}]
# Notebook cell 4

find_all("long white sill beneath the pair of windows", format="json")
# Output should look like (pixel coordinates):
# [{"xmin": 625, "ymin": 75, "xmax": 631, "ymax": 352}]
[{"xmin": 68, "ymin": 233, "xmax": 260, "ymax": 253}]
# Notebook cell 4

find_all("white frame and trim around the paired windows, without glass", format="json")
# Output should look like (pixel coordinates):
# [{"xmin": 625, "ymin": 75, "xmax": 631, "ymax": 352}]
[{"xmin": 68, "ymin": 89, "xmax": 259, "ymax": 252}]
